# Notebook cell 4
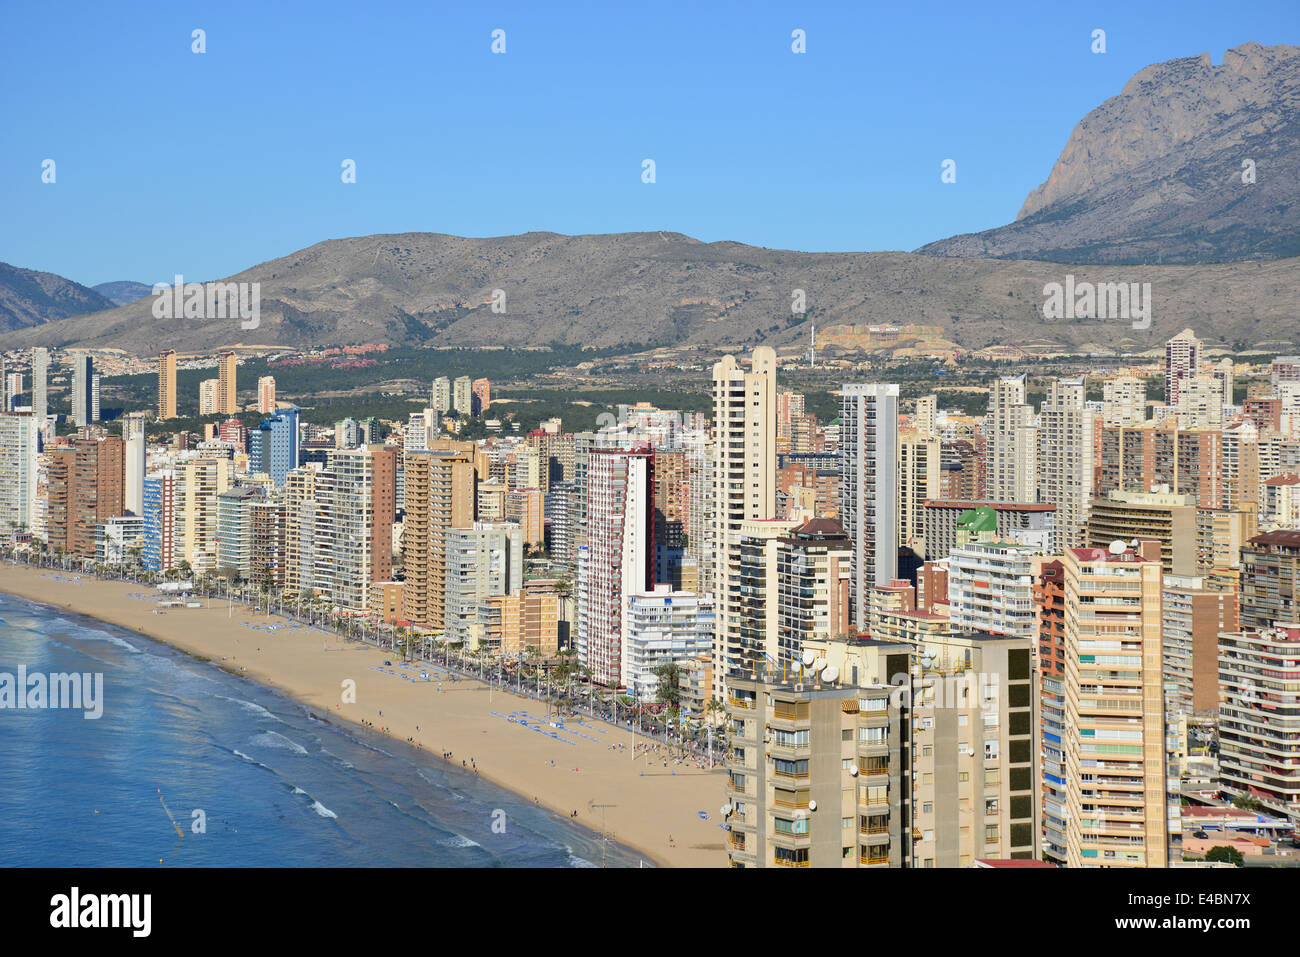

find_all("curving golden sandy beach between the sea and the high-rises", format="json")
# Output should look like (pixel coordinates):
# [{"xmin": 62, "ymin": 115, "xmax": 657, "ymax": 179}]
[{"xmin": 0, "ymin": 564, "xmax": 727, "ymax": 867}]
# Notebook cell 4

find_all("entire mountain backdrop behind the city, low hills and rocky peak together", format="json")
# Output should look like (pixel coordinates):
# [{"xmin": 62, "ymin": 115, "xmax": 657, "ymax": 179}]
[{"xmin": 0, "ymin": 43, "xmax": 1300, "ymax": 355}]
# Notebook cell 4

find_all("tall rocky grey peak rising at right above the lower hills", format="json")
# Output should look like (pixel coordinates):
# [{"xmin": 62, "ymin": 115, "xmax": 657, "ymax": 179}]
[{"xmin": 918, "ymin": 43, "xmax": 1300, "ymax": 264}]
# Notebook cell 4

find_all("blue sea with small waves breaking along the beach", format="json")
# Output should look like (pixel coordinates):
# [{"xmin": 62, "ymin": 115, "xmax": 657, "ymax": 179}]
[{"xmin": 0, "ymin": 594, "xmax": 650, "ymax": 867}]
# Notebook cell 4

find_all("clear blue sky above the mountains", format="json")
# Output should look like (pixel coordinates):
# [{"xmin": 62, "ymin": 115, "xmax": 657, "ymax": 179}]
[{"xmin": 0, "ymin": 0, "xmax": 1300, "ymax": 285}]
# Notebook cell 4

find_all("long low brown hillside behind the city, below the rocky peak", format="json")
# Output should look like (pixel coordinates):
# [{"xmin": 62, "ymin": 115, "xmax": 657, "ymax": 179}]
[{"xmin": 0, "ymin": 233, "xmax": 1300, "ymax": 355}]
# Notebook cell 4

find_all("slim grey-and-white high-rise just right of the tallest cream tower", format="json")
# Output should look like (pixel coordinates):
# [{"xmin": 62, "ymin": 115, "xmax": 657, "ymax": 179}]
[{"xmin": 840, "ymin": 382, "xmax": 898, "ymax": 628}]
